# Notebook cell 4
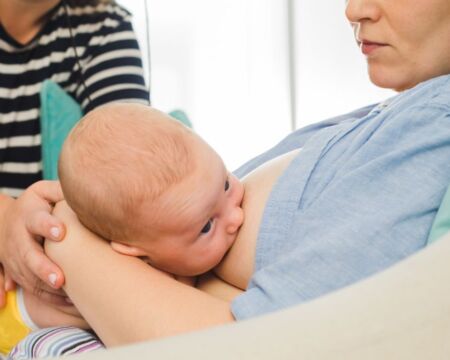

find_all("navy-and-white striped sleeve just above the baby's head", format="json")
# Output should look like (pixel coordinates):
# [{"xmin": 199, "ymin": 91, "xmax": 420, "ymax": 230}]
[{"xmin": 77, "ymin": 6, "xmax": 149, "ymax": 112}]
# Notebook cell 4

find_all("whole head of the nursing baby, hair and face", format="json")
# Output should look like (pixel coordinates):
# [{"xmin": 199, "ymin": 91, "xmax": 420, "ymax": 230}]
[{"xmin": 59, "ymin": 103, "xmax": 243, "ymax": 275}]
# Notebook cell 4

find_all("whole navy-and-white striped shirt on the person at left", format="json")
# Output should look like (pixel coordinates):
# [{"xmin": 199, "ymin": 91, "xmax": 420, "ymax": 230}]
[{"xmin": 0, "ymin": 3, "xmax": 149, "ymax": 196}]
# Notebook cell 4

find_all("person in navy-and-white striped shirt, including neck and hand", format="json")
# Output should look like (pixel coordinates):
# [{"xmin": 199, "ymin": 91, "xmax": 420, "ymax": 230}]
[{"xmin": 0, "ymin": 0, "xmax": 149, "ymax": 306}]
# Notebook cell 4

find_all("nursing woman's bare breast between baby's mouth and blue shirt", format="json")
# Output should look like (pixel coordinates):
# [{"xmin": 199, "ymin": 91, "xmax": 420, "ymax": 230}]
[{"xmin": 210, "ymin": 150, "xmax": 300, "ymax": 290}]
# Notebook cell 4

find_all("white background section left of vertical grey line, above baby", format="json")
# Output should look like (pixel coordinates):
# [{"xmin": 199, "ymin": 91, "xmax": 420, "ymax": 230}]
[{"xmin": 119, "ymin": 0, "xmax": 290, "ymax": 169}]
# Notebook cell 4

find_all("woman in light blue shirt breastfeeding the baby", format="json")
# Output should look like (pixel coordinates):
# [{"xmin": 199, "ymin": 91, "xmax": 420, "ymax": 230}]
[{"xmin": 4, "ymin": 0, "xmax": 450, "ymax": 354}]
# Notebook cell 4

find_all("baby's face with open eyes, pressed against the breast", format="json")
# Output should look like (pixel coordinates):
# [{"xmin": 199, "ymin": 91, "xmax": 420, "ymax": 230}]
[{"xmin": 127, "ymin": 141, "xmax": 244, "ymax": 276}]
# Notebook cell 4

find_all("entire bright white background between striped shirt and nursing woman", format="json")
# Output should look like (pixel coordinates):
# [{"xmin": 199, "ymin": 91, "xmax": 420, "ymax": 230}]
[{"xmin": 119, "ymin": 0, "xmax": 391, "ymax": 169}]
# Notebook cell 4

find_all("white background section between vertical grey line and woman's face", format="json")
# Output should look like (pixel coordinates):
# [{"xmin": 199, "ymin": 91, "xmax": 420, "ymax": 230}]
[{"xmin": 295, "ymin": 0, "xmax": 393, "ymax": 127}]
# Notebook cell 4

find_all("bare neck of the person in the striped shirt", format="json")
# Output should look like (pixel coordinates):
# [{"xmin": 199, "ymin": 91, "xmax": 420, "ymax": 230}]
[{"xmin": 0, "ymin": 0, "xmax": 61, "ymax": 44}]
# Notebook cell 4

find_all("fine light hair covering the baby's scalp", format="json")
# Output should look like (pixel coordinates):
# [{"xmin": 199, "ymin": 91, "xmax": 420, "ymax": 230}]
[{"xmin": 59, "ymin": 103, "xmax": 197, "ymax": 241}]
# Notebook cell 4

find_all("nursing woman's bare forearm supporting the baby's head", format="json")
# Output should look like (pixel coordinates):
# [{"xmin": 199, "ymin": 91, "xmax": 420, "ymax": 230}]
[{"xmin": 45, "ymin": 202, "xmax": 233, "ymax": 346}]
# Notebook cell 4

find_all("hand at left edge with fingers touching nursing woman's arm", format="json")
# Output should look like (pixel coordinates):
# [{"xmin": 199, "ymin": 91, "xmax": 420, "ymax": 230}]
[{"xmin": 0, "ymin": 181, "xmax": 65, "ymax": 304}]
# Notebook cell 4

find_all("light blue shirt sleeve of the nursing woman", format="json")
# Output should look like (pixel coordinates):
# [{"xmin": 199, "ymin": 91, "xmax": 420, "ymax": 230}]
[{"xmin": 232, "ymin": 95, "xmax": 450, "ymax": 319}]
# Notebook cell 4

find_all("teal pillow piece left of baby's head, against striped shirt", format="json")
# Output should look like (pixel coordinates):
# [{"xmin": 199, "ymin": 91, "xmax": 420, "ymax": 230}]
[{"xmin": 40, "ymin": 80, "xmax": 83, "ymax": 180}]
